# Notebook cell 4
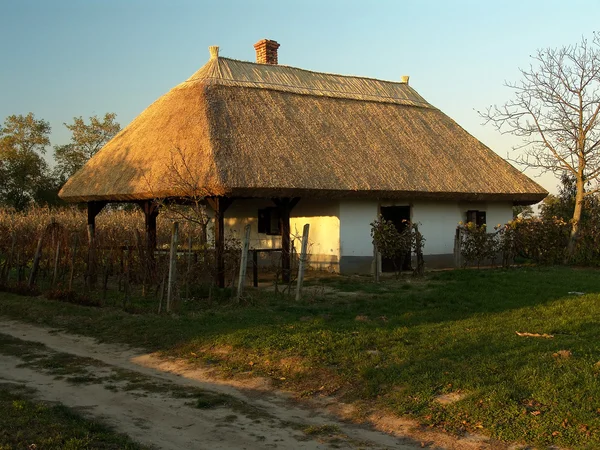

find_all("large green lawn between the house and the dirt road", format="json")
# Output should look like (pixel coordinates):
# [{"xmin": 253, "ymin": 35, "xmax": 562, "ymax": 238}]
[{"xmin": 0, "ymin": 268, "xmax": 600, "ymax": 449}]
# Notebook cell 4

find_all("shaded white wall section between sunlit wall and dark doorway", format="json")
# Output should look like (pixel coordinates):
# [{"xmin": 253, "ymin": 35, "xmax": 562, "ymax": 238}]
[{"xmin": 339, "ymin": 200, "xmax": 379, "ymax": 256}]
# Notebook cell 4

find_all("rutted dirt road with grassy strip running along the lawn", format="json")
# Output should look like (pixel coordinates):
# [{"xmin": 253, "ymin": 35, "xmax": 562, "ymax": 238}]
[{"xmin": 0, "ymin": 319, "xmax": 506, "ymax": 450}]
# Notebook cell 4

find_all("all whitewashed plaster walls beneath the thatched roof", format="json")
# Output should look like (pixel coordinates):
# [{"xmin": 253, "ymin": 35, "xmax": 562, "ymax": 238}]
[{"xmin": 209, "ymin": 199, "xmax": 512, "ymax": 262}]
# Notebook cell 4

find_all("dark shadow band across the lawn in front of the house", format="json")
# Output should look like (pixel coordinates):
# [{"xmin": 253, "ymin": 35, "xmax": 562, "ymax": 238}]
[{"xmin": 0, "ymin": 267, "xmax": 600, "ymax": 350}]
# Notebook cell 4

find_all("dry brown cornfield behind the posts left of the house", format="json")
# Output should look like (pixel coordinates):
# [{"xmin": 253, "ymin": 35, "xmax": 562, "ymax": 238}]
[{"xmin": 0, "ymin": 207, "xmax": 244, "ymax": 306}]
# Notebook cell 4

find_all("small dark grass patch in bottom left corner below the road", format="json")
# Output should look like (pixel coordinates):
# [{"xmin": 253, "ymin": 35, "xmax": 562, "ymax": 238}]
[{"xmin": 0, "ymin": 383, "xmax": 148, "ymax": 450}]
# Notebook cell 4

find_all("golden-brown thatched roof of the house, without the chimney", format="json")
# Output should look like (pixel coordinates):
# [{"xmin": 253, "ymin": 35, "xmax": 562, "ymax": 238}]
[{"xmin": 60, "ymin": 51, "xmax": 547, "ymax": 203}]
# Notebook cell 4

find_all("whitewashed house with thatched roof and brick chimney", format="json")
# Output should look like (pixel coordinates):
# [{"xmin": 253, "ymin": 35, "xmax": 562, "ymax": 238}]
[{"xmin": 60, "ymin": 40, "xmax": 547, "ymax": 284}]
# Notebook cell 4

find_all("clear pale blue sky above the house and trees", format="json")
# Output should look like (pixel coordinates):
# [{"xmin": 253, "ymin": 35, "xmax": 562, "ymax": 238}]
[{"xmin": 0, "ymin": 0, "xmax": 600, "ymax": 191}]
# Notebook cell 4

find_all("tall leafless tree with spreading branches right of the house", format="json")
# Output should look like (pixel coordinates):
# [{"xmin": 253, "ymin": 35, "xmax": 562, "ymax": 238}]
[{"xmin": 480, "ymin": 34, "xmax": 600, "ymax": 257}]
